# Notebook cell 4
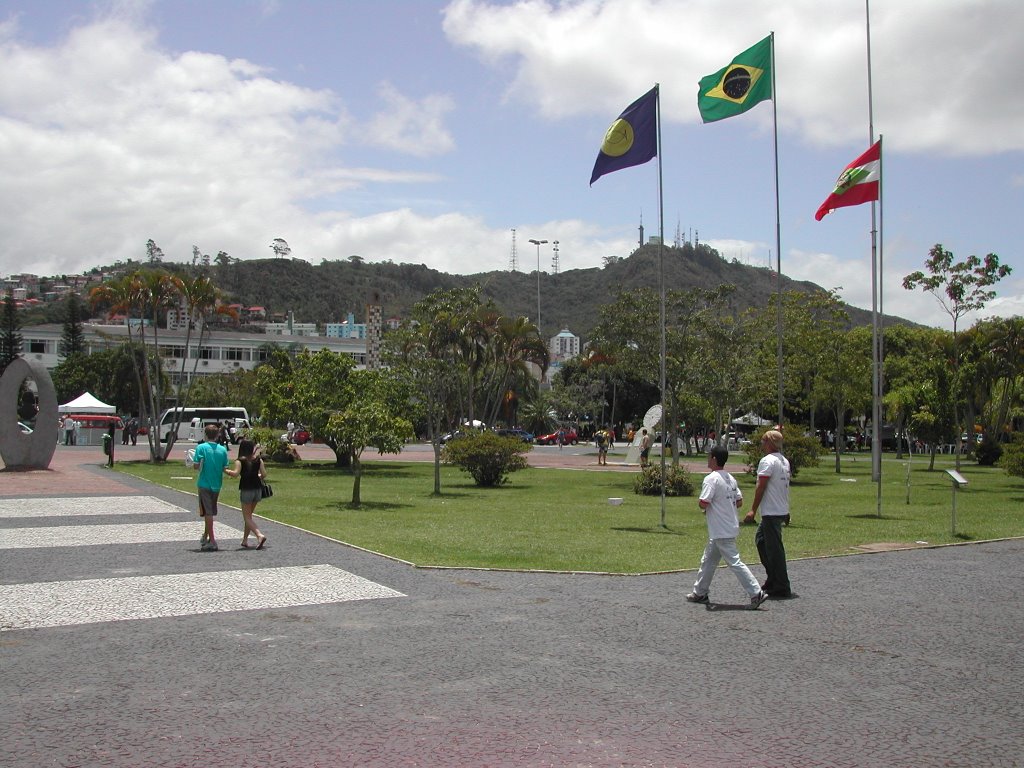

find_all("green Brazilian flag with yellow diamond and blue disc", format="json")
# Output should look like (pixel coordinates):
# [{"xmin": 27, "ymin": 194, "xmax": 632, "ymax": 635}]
[{"xmin": 697, "ymin": 35, "xmax": 772, "ymax": 123}]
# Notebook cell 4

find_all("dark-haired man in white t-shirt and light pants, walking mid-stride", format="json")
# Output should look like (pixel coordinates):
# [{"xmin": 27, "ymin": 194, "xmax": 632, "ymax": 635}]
[{"xmin": 686, "ymin": 445, "xmax": 768, "ymax": 610}]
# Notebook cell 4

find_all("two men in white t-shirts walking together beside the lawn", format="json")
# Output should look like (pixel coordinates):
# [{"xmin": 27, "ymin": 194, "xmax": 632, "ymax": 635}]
[{"xmin": 686, "ymin": 429, "xmax": 794, "ymax": 610}]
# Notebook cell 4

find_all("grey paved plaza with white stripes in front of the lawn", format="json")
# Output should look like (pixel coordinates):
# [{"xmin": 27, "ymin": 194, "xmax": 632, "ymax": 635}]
[{"xmin": 0, "ymin": 446, "xmax": 1024, "ymax": 768}]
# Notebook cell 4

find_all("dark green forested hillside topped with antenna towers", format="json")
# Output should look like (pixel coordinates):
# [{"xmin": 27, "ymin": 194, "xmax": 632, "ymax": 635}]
[{"xmin": 25, "ymin": 244, "xmax": 905, "ymax": 340}]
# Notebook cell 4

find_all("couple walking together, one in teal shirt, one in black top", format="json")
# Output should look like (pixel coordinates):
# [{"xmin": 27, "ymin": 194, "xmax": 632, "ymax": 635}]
[{"xmin": 193, "ymin": 424, "xmax": 266, "ymax": 552}]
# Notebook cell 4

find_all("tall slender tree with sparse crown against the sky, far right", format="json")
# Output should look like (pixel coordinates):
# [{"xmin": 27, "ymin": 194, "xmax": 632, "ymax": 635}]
[{"xmin": 903, "ymin": 244, "xmax": 1013, "ymax": 469}]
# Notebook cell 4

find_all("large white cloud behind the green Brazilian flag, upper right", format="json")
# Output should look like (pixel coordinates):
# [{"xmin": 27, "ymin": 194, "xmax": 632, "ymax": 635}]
[{"xmin": 444, "ymin": 0, "xmax": 1024, "ymax": 155}]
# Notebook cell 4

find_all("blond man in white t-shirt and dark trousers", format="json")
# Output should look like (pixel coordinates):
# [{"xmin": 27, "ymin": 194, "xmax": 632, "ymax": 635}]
[{"xmin": 743, "ymin": 429, "xmax": 793, "ymax": 598}]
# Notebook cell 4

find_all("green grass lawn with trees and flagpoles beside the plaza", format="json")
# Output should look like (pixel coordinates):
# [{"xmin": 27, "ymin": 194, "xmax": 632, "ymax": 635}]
[{"xmin": 117, "ymin": 454, "xmax": 1024, "ymax": 573}]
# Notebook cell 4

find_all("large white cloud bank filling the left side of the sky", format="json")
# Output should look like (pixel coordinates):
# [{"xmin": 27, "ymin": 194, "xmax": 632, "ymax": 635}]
[{"xmin": 0, "ymin": 18, "xmax": 451, "ymax": 273}]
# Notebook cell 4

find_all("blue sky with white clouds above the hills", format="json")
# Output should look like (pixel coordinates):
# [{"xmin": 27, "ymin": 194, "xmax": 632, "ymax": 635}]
[{"xmin": 0, "ymin": 0, "xmax": 1024, "ymax": 328}]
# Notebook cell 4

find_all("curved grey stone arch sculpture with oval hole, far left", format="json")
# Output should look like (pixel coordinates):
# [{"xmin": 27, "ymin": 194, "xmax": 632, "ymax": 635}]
[{"xmin": 0, "ymin": 357, "xmax": 57, "ymax": 469}]
